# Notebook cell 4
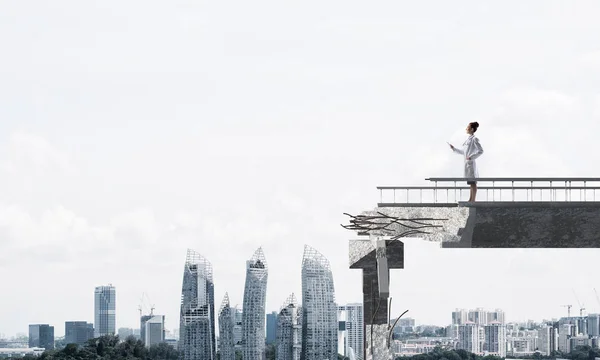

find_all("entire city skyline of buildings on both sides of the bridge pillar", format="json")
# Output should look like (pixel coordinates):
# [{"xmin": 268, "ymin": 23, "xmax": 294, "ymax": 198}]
[{"xmin": 9, "ymin": 250, "xmax": 600, "ymax": 360}]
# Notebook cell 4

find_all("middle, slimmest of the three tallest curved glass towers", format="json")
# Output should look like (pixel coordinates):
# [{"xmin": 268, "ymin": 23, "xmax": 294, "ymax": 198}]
[{"xmin": 242, "ymin": 248, "xmax": 269, "ymax": 360}]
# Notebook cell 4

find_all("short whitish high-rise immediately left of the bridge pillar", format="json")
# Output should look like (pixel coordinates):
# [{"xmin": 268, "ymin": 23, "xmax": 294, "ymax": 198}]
[{"xmin": 338, "ymin": 304, "xmax": 366, "ymax": 360}]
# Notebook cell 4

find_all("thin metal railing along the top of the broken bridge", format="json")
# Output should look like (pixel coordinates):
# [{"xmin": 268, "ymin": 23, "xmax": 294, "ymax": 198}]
[{"xmin": 377, "ymin": 178, "xmax": 600, "ymax": 206}]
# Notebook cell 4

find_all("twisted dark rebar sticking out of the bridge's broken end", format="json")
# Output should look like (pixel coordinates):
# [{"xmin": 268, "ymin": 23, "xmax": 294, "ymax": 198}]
[{"xmin": 341, "ymin": 212, "xmax": 448, "ymax": 240}]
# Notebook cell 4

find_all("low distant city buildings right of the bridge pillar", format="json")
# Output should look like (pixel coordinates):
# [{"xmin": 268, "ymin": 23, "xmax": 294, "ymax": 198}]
[{"xmin": 394, "ymin": 308, "xmax": 600, "ymax": 358}]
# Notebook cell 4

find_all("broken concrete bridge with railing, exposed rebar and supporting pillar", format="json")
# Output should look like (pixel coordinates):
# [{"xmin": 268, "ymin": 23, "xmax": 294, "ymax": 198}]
[{"xmin": 342, "ymin": 178, "xmax": 600, "ymax": 360}]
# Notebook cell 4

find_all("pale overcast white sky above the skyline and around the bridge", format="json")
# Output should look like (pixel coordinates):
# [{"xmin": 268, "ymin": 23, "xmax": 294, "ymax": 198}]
[{"xmin": 0, "ymin": 0, "xmax": 600, "ymax": 336}]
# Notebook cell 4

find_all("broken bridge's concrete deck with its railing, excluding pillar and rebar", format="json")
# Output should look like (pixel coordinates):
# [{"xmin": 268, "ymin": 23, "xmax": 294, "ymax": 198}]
[{"xmin": 370, "ymin": 178, "xmax": 600, "ymax": 248}]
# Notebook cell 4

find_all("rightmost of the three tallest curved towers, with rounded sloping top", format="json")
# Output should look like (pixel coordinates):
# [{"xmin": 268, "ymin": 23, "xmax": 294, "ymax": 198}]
[{"xmin": 301, "ymin": 245, "xmax": 338, "ymax": 360}]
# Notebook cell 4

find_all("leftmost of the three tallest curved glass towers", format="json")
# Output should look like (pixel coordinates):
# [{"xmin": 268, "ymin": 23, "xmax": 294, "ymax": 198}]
[{"xmin": 179, "ymin": 249, "xmax": 217, "ymax": 360}]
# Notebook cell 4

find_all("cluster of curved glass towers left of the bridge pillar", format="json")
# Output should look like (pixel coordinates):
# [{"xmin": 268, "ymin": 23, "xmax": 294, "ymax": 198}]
[{"xmin": 179, "ymin": 246, "xmax": 344, "ymax": 360}]
